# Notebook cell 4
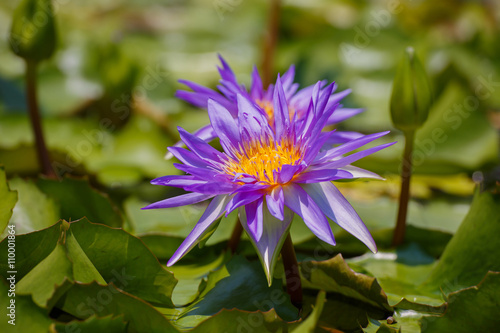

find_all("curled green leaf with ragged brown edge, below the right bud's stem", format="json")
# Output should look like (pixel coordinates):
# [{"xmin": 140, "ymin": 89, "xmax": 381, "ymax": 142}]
[{"xmin": 299, "ymin": 254, "xmax": 393, "ymax": 330}]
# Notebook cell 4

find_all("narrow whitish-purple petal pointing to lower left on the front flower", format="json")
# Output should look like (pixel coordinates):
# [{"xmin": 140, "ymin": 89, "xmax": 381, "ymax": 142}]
[{"xmin": 167, "ymin": 195, "xmax": 230, "ymax": 266}]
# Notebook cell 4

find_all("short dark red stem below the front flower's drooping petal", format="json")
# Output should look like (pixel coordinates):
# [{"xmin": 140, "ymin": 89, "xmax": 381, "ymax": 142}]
[{"xmin": 281, "ymin": 233, "xmax": 302, "ymax": 311}]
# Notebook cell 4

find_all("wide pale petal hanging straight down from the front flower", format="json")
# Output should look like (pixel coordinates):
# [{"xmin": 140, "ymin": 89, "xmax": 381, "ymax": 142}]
[{"xmin": 239, "ymin": 203, "xmax": 293, "ymax": 285}]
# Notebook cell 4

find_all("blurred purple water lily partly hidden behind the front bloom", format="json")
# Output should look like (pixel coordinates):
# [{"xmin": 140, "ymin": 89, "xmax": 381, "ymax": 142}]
[{"xmin": 172, "ymin": 55, "xmax": 363, "ymax": 148}]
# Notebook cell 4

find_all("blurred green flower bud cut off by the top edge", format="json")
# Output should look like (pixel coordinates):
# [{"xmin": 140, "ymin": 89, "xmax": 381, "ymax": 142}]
[{"xmin": 10, "ymin": 0, "xmax": 56, "ymax": 62}]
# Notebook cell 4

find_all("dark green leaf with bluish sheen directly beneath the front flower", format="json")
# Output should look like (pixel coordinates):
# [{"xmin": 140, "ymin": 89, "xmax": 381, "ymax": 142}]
[{"xmin": 172, "ymin": 256, "xmax": 298, "ymax": 328}]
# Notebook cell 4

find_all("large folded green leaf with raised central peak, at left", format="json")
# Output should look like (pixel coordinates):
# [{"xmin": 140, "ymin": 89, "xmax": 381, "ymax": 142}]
[{"xmin": 0, "ymin": 219, "xmax": 176, "ymax": 307}]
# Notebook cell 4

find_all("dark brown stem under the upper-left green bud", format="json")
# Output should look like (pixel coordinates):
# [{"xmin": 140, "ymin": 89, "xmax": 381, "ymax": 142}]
[{"xmin": 26, "ymin": 60, "xmax": 55, "ymax": 178}]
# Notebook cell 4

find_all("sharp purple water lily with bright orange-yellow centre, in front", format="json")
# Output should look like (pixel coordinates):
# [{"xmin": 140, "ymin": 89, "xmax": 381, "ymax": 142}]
[{"xmin": 148, "ymin": 76, "xmax": 393, "ymax": 284}]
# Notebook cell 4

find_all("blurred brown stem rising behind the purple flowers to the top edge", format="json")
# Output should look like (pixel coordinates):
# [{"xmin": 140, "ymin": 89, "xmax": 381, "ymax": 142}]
[{"xmin": 262, "ymin": 0, "xmax": 281, "ymax": 87}]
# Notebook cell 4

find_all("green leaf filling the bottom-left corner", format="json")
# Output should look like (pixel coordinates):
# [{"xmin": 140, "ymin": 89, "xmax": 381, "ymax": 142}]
[{"xmin": 0, "ymin": 281, "xmax": 52, "ymax": 333}]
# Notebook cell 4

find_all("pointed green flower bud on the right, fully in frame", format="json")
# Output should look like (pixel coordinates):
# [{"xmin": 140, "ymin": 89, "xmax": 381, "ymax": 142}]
[{"xmin": 391, "ymin": 47, "xmax": 432, "ymax": 131}]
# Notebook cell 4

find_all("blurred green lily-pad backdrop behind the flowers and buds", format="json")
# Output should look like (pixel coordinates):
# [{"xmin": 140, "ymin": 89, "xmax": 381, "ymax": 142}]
[{"xmin": 0, "ymin": 0, "xmax": 500, "ymax": 186}]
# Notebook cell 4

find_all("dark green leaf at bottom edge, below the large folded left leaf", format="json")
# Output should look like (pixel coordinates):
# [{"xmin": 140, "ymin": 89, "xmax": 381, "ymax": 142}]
[{"xmin": 54, "ymin": 283, "xmax": 178, "ymax": 333}]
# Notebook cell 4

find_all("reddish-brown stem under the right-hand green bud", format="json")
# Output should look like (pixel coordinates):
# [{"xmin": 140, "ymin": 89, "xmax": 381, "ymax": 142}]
[{"xmin": 392, "ymin": 131, "xmax": 415, "ymax": 246}]
